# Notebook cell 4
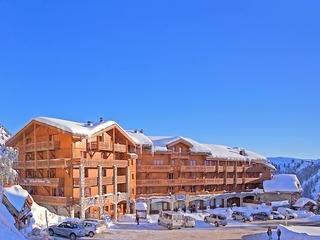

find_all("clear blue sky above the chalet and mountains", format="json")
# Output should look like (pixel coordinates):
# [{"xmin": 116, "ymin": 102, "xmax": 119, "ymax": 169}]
[{"xmin": 0, "ymin": 0, "xmax": 320, "ymax": 158}]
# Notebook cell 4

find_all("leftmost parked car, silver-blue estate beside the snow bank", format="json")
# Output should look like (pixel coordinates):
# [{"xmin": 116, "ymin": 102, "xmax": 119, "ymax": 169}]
[{"xmin": 49, "ymin": 222, "xmax": 86, "ymax": 240}]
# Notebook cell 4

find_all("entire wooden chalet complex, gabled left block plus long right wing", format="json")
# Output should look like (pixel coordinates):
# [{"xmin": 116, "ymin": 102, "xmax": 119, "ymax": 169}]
[{"xmin": 6, "ymin": 117, "xmax": 275, "ymax": 219}]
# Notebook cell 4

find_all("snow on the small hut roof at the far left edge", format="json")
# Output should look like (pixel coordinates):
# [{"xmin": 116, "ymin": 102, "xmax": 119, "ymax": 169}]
[{"xmin": 3, "ymin": 185, "xmax": 29, "ymax": 212}]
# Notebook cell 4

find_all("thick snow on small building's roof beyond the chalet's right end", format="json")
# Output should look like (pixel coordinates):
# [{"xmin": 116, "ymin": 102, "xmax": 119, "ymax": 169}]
[{"xmin": 263, "ymin": 174, "xmax": 302, "ymax": 193}]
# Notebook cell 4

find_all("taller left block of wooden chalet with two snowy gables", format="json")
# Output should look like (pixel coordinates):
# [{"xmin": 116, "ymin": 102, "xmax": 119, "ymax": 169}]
[{"xmin": 6, "ymin": 117, "xmax": 136, "ymax": 218}]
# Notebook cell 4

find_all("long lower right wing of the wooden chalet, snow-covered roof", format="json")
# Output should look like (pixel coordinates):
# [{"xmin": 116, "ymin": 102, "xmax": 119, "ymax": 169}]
[{"xmin": 128, "ymin": 131, "xmax": 276, "ymax": 213}]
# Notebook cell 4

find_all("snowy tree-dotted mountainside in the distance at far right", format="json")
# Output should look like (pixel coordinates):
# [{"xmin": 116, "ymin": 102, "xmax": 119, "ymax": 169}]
[{"xmin": 268, "ymin": 157, "xmax": 320, "ymax": 200}]
